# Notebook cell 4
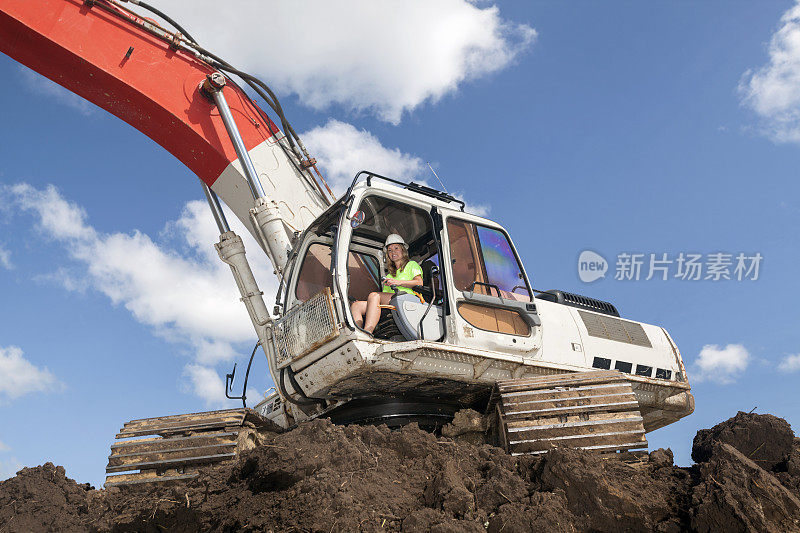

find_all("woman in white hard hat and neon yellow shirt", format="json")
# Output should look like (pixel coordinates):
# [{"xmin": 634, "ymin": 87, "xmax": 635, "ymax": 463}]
[{"xmin": 350, "ymin": 233, "xmax": 422, "ymax": 333}]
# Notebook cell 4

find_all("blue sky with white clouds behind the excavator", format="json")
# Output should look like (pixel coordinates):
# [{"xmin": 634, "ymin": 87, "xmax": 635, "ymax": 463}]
[{"xmin": 0, "ymin": 0, "xmax": 800, "ymax": 485}]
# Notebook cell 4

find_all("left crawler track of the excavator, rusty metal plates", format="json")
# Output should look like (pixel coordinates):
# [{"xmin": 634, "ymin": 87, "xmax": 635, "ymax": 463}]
[{"xmin": 105, "ymin": 409, "xmax": 270, "ymax": 488}]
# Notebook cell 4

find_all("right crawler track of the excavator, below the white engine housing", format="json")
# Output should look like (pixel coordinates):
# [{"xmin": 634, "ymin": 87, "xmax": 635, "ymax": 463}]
[{"xmin": 493, "ymin": 371, "xmax": 647, "ymax": 455}]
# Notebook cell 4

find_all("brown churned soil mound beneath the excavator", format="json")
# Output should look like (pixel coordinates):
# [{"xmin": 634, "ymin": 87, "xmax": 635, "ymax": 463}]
[{"xmin": 0, "ymin": 413, "xmax": 800, "ymax": 533}]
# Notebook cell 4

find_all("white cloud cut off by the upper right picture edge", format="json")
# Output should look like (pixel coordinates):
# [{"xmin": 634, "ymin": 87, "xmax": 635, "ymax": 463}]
[{"xmin": 739, "ymin": 4, "xmax": 800, "ymax": 142}]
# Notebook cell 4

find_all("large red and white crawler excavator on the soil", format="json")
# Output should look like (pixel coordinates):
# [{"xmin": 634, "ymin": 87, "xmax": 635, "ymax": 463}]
[{"xmin": 0, "ymin": 0, "xmax": 694, "ymax": 487}]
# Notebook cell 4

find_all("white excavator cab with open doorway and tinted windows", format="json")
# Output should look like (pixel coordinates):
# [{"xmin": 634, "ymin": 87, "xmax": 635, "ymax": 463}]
[{"xmin": 283, "ymin": 169, "xmax": 541, "ymax": 353}]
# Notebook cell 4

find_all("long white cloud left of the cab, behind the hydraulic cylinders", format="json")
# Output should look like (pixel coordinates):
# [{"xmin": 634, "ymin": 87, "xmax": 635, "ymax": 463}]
[{"xmin": 8, "ymin": 184, "xmax": 277, "ymax": 398}]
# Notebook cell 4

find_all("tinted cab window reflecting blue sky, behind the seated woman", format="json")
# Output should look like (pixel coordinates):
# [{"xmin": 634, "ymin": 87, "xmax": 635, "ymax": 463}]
[{"xmin": 447, "ymin": 219, "xmax": 531, "ymax": 302}]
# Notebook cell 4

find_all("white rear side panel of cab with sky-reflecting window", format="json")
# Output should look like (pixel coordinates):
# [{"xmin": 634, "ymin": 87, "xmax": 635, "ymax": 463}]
[{"xmin": 443, "ymin": 214, "xmax": 541, "ymax": 353}]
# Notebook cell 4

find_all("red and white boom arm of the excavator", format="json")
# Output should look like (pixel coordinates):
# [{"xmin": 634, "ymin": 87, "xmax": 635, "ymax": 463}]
[{"xmin": 0, "ymin": 0, "xmax": 330, "ymax": 275}]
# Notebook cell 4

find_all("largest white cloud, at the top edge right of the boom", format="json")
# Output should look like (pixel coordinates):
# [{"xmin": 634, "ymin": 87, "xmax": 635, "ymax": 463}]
[{"xmin": 159, "ymin": 0, "xmax": 536, "ymax": 124}]
